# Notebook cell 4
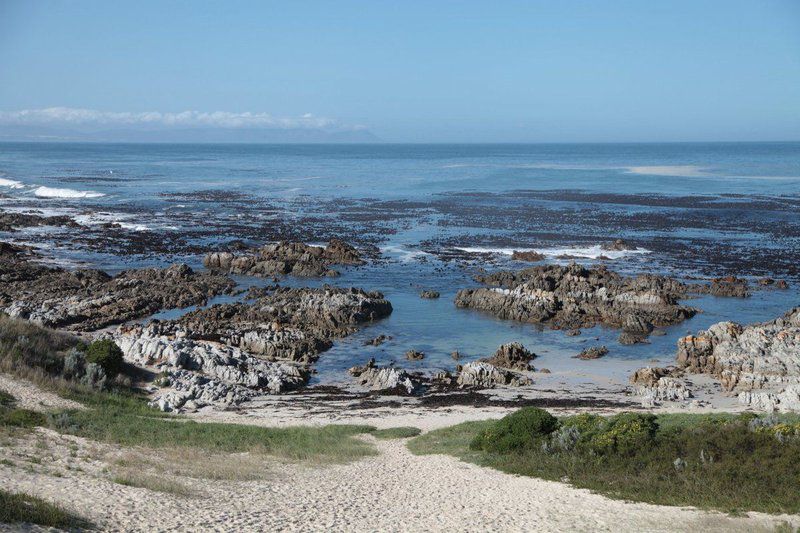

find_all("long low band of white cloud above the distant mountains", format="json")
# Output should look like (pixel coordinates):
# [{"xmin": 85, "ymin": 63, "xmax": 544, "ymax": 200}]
[{"xmin": 0, "ymin": 107, "xmax": 361, "ymax": 130}]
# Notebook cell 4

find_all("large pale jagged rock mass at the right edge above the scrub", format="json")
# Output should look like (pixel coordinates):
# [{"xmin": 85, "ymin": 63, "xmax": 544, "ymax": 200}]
[{"xmin": 677, "ymin": 308, "xmax": 800, "ymax": 391}]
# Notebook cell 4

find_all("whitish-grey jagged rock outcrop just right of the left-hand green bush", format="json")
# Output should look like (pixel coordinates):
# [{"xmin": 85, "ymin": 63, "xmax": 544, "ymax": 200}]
[{"xmin": 113, "ymin": 322, "xmax": 309, "ymax": 410}]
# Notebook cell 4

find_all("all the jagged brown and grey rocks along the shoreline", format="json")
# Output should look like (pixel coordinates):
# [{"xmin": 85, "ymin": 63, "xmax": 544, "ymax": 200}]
[{"xmin": 0, "ymin": 231, "xmax": 800, "ymax": 411}]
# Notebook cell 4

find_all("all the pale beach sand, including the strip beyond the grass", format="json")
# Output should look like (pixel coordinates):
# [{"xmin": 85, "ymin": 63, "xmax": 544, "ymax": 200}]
[{"xmin": 0, "ymin": 377, "xmax": 800, "ymax": 532}]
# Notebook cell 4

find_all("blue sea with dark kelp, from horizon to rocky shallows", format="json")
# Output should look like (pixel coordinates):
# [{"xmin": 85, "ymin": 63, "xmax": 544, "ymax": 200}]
[{"xmin": 0, "ymin": 143, "xmax": 800, "ymax": 382}]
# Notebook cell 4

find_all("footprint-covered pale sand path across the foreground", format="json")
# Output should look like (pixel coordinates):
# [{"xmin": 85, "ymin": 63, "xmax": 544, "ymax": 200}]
[{"xmin": 0, "ymin": 437, "xmax": 792, "ymax": 532}]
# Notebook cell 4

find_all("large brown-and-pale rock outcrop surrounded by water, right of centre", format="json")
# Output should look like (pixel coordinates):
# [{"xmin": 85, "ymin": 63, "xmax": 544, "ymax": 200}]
[{"xmin": 455, "ymin": 264, "xmax": 696, "ymax": 338}]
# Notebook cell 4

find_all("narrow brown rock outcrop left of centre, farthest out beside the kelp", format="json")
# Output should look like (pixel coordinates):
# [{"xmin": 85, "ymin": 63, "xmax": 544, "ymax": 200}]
[{"xmin": 203, "ymin": 239, "xmax": 364, "ymax": 277}]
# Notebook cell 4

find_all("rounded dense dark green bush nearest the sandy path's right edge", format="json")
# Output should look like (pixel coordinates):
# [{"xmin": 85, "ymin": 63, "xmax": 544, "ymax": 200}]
[{"xmin": 470, "ymin": 407, "xmax": 558, "ymax": 454}]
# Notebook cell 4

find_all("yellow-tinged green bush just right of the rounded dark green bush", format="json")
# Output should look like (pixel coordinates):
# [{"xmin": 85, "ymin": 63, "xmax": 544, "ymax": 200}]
[{"xmin": 588, "ymin": 413, "xmax": 658, "ymax": 456}]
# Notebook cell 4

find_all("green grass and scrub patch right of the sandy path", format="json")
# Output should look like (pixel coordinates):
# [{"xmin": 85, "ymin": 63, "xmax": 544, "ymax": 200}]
[{"xmin": 408, "ymin": 415, "xmax": 800, "ymax": 513}]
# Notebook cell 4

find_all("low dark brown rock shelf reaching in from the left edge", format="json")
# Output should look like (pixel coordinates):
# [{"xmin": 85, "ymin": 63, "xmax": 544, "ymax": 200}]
[{"xmin": 0, "ymin": 247, "xmax": 235, "ymax": 331}]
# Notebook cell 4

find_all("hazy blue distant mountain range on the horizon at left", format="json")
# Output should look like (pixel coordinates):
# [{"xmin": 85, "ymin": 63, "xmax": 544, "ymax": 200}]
[{"xmin": 0, "ymin": 125, "xmax": 382, "ymax": 144}]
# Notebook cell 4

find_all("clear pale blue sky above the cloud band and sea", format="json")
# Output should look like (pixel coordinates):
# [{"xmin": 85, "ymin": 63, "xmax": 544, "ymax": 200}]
[{"xmin": 0, "ymin": 0, "xmax": 800, "ymax": 142}]
